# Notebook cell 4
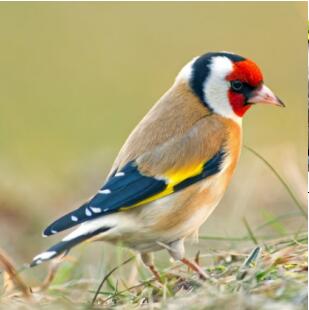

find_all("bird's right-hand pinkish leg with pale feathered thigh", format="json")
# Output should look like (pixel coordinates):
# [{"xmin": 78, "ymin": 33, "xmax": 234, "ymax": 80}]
[{"xmin": 168, "ymin": 239, "xmax": 208, "ymax": 280}]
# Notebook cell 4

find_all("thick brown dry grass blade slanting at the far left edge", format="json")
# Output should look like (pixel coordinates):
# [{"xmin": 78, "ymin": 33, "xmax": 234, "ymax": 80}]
[{"xmin": 0, "ymin": 250, "xmax": 31, "ymax": 298}]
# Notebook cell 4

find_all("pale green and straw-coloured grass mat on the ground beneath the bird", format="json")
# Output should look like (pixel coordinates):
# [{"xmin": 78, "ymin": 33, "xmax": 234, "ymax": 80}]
[{"xmin": 1, "ymin": 233, "xmax": 308, "ymax": 309}]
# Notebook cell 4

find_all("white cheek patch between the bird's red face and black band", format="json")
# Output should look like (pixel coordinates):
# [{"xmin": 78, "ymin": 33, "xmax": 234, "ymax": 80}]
[{"xmin": 204, "ymin": 56, "xmax": 241, "ymax": 124}]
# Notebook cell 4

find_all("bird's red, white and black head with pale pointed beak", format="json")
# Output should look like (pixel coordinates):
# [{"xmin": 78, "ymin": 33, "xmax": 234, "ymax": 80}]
[{"xmin": 178, "ymin": 52, "xmax": 284, "ymax": 119}]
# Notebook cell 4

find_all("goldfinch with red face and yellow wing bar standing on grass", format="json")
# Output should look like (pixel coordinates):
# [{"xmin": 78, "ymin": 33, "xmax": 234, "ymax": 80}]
[{"xmin": 30, "ymin": 52, "xmax": 284, "ymax": 280}]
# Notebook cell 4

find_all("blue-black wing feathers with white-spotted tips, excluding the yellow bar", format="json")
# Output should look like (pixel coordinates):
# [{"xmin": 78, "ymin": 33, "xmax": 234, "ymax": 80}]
[{"xmin": 43, "ymin": 150, "xmax": 225, "ymax": 236}]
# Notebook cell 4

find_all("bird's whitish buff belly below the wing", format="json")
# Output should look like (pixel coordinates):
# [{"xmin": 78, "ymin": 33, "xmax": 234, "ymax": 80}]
[{"xmin": 102, "ymin": 174, "xmax": 223, "ymax": 252}]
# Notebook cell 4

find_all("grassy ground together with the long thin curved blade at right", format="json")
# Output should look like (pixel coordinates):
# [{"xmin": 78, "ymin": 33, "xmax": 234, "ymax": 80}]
[{"xmin": 0, "ymin": 148, "xmax": 308, "ymax": 310}]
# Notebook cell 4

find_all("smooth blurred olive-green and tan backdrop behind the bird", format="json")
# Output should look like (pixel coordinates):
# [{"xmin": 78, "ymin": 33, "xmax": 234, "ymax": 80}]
[{"xmin": 0, "ymin": 2, "xmax": 307, "ymax": 274}]
